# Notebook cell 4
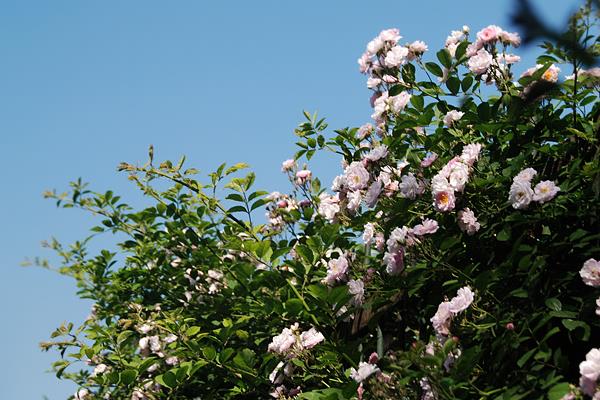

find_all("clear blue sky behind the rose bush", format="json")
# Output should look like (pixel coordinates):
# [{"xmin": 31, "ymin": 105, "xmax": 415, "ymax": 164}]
[{"xmin": 0, "ymin": 0, "xmax": 579, "ymax": 400}]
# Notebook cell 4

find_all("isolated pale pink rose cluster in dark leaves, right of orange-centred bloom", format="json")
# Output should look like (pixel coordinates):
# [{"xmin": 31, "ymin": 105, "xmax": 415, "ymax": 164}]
[{"xmin": 508, "ymin": 168, "xmax": 560, "ymax": 210}]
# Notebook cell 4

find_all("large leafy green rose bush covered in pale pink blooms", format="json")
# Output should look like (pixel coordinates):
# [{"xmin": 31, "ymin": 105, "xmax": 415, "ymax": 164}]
[{"xmin": 42, "ymin": 6, "xmax": 600, "ymax": 400}]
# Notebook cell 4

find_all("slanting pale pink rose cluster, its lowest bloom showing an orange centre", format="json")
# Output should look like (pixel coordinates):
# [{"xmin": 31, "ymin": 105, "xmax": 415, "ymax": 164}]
[{"xmin": 431, "ymin": 143, "xmax": 482, "ymax": 212}]
